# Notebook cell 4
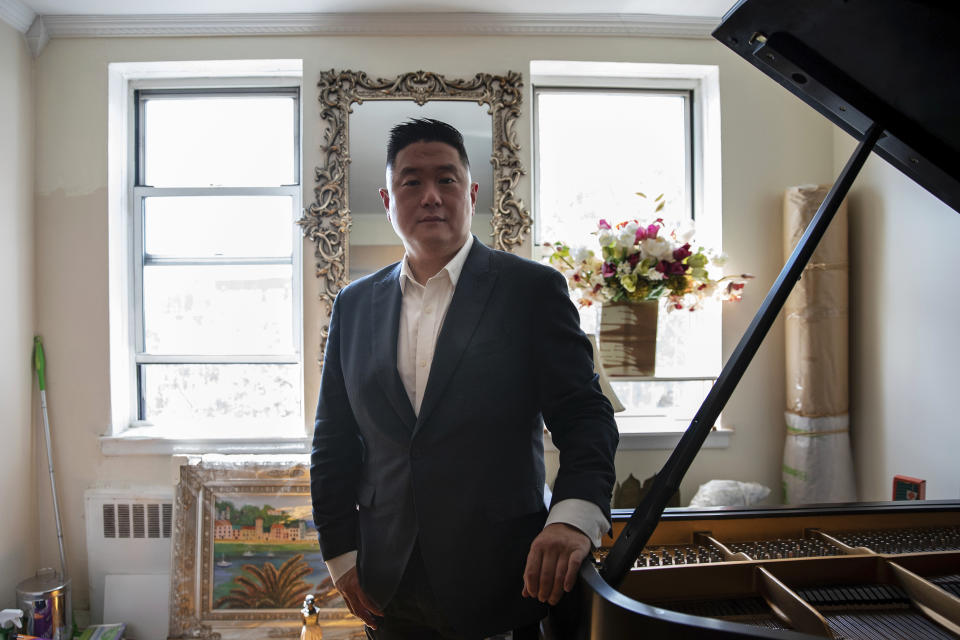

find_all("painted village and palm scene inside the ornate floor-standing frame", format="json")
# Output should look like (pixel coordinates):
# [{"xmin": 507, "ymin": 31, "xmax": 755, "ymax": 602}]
[{"xmin": 212, "ymin": 494, "xmax": 344, "ymax": 610}]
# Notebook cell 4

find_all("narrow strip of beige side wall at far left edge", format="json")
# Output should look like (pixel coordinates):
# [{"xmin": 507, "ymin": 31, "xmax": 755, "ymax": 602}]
[{"xmin": 0, "ymin": 22, "xmax": 37, "ymax": 608}]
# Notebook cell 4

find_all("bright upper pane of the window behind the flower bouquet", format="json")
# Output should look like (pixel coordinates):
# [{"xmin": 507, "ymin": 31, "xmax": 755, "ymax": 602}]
[{"xmin": 537, "ymin": 91, "xmax": 691, "ymax": 248}]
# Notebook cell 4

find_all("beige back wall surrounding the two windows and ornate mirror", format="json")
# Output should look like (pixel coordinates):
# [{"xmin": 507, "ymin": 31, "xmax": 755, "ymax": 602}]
[{"xmin": 36, "ymin": 31, "xmax": 832, "ymax": 608}]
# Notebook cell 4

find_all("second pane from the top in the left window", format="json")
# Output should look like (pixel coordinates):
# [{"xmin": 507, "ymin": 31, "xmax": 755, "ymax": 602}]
[{"xmin": 143, "ymin": 196, "xmax": 294, "ymax": 258}]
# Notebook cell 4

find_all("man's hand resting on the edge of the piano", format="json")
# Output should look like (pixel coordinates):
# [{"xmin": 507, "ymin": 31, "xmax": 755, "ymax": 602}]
[{"xmin": 523, "ymin": 522, "xmax": 590, "ymax": 605}]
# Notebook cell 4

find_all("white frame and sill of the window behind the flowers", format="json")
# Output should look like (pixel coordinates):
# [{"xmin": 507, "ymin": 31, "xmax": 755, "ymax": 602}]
[{"xmin": 530, "ymin": 60, "xmax": 729, "ymax": 449}]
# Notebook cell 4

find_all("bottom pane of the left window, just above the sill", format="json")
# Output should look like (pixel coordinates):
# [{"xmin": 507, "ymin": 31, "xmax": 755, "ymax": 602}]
[{"xmin": 141, "ymin": 364, "xmax": 301, "ymax": 421}]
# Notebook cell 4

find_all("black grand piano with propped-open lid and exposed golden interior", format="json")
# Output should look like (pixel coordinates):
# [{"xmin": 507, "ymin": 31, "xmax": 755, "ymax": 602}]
[{"xmin": 547, "ymin": 0, "xmax": 960, "ymax": 640}]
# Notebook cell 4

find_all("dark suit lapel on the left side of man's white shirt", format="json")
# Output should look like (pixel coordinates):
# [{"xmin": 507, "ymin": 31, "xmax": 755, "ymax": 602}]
[{"xmin": 370, "ymin": 264, "xmax": 416, "ymax": 430}]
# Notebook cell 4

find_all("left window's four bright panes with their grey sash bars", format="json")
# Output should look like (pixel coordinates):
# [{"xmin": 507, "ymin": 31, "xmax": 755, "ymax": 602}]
[{"xmin": 127, "ymin": 79, "xmax": 303, "ymax": 437}]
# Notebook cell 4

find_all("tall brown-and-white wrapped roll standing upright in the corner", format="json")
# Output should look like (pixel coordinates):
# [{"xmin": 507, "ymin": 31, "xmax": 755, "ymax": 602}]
[{"xmin": 783, "ymin": 185, "xmax": 856, "ymax": 504}]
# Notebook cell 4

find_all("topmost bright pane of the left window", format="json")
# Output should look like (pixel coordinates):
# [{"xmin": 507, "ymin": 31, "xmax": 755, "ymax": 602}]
[{"xmin": 143, "ymin": 96, "xmax": 296, "ymax": 187}]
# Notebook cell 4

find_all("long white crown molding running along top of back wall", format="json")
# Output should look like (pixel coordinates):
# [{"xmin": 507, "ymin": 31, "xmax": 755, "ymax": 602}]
[{"xmin": 41, "ymin": 11, "xmax": 720, "ymax": 38}]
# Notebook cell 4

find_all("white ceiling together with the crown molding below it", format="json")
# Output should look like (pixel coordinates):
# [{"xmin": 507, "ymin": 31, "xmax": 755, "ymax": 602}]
[{"xmin": 0, "ymin": 0, "xmax": 736, "ymax": 56}]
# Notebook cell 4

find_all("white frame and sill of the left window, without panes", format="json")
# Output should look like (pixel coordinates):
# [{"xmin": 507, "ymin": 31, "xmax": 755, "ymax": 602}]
[{"xmin": 101, "ymin": 60, "xmax": 307, "ymax": 455}]
